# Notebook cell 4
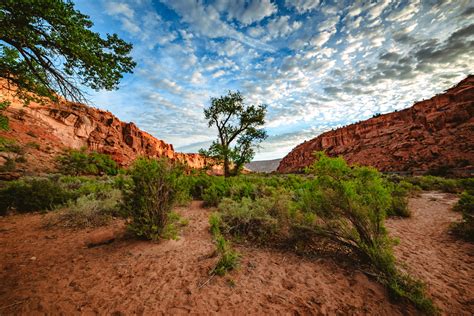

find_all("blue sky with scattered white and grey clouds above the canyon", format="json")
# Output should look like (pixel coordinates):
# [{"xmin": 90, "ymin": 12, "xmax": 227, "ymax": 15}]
[{"xmin": 75, "ymin": 0, "xmax": 474, "ymax": 160}]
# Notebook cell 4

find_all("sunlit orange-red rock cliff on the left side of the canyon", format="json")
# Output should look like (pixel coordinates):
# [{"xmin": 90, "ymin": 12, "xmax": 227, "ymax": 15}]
[{"xmin": 0, "ymin": 81, "xmax": 211, "ymax": 171}]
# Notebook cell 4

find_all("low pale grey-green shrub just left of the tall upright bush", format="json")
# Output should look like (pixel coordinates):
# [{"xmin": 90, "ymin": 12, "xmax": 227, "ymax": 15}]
[{"xmin": 46, "ymin": 189, "xmax": 122, "ymax": 228}]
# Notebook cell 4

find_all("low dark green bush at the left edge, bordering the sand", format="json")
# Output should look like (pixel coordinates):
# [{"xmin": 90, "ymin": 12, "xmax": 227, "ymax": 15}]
[{"xmin": 0, "ymin": 178, "xmax": 73, "ymax": 214}]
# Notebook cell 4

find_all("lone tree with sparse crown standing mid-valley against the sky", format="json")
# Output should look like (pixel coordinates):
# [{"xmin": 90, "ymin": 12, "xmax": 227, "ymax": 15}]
[{"xmin": 199, "ymin": 91, "xmax": 267, "ymax": 177}]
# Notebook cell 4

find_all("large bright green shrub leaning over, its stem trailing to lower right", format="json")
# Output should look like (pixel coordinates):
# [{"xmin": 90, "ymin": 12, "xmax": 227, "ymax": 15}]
[{"xmin": 306, "ymin": 153, "xmax": 434, "ymax": 312}]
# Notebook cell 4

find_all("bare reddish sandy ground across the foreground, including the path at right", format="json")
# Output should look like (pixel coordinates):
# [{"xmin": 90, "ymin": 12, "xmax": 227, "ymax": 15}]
[{"xmin": 0, "ymin": 195, "xmax": 473, "ymax": 315}]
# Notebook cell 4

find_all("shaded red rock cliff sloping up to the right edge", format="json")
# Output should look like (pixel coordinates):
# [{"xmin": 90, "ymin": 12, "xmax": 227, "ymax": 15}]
[{"xmin": 278, "ymin": 75, "xmax": 474, "ymax": 176}]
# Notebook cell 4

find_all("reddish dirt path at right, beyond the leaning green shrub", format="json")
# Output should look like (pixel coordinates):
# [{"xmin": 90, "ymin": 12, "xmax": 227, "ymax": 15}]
[{"xmin": 387, "ymin": 192, "xmax": 474, "ymax": 315}]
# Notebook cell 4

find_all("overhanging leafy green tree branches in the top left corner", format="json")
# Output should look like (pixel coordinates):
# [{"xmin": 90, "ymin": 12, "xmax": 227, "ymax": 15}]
[{"xmin": 0, "ymin": 0, "xmax": 136, "ymax": 128}]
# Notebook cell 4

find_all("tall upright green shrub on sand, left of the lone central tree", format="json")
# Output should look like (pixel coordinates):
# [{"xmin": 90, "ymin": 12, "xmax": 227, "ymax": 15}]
[{"xmin": 124, "ymin": 158, "xmax": 183, "ymax": 240}]
